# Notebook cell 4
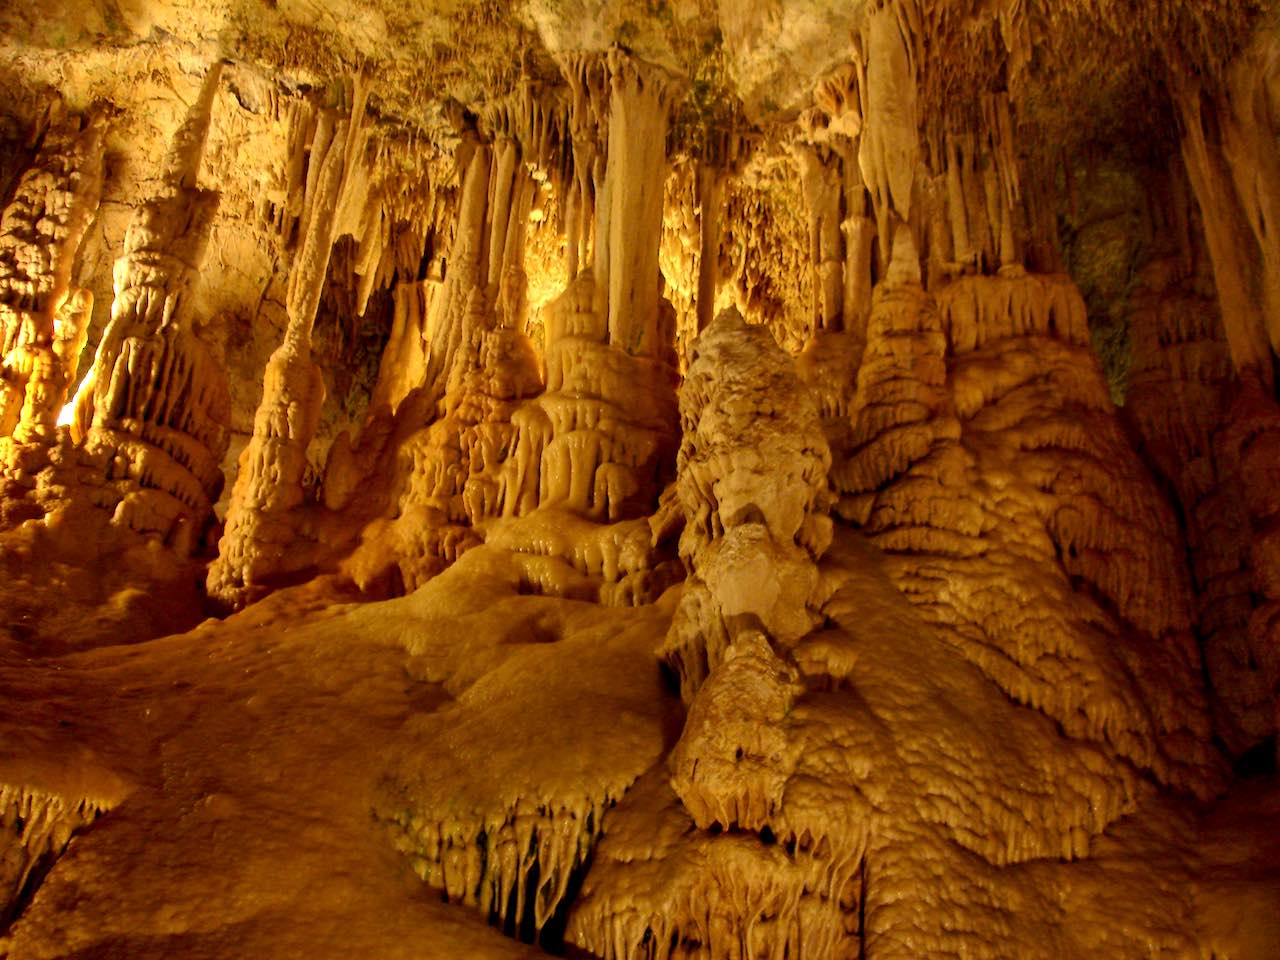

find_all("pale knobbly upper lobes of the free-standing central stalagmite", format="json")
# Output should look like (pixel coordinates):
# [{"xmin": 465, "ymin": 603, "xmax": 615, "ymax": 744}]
[{"xmin": 663, "ymin": 310, "xmax": 831, "ymax": 699}]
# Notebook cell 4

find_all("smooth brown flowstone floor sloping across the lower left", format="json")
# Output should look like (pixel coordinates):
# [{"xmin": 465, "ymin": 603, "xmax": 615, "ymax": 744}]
[{"xmin": 0, "ymin": 537, "xmax": 1280, "ymax": 960}]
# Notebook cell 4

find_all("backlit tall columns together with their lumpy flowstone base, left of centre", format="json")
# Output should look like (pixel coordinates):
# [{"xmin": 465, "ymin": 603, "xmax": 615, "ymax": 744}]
[{"xmin": 276, "ymin": 51, "xmax": 691, "ymax": 609}]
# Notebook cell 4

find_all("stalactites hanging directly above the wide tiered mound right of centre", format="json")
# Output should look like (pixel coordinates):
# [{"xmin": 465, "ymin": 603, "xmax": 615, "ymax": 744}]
[{"xmin": 792, "ymin": 0, "xmax": 1059, "ymax": 316}]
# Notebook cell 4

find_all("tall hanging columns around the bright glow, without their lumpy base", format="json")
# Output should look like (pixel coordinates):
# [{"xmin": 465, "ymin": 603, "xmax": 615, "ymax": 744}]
[{"xmin": 373, "ymin": 50, "xmax": 675, "ymax": 419}]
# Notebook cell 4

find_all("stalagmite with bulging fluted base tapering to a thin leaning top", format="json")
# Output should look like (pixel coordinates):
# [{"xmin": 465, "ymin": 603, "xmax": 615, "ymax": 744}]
[{"xmin": 61, "ymin": 63, "xmax": 229, "ymax": 554}]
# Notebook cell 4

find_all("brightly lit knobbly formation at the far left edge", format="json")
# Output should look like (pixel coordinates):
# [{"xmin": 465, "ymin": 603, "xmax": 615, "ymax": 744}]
[{"xmin": 0, "ymin": 108, "xmax": 102, "ymax": 442}]
